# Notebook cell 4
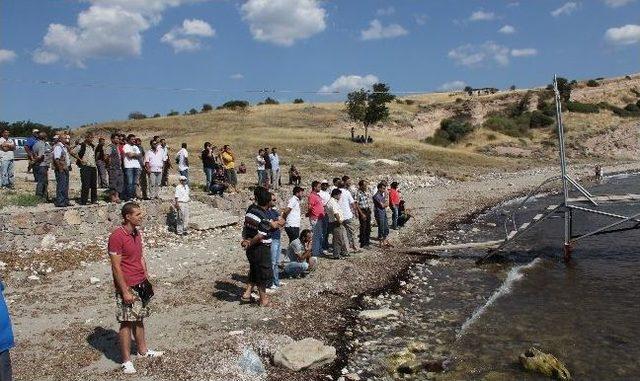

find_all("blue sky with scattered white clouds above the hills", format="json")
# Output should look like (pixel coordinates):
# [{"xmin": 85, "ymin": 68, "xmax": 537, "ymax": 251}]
[{"xmin": 0, "ymin": 0, "xmax": 640, "ymax": 127}]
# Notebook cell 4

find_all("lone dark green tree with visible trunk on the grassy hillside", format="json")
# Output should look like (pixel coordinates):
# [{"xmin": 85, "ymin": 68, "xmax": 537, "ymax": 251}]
[{"xmin": 345, "ymin": 83, "xmax": 396, "ymax": 142}]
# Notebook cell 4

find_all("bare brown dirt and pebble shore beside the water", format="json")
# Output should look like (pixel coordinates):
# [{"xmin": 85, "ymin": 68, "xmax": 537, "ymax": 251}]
[{"xmin": 6, "ymin": 164, "xmax": 638, "ymax": 380}]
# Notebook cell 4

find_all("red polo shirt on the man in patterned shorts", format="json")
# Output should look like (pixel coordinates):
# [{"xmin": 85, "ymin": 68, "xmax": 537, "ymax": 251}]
[{"xmin": 107, "ymin": 226, "xmax": 145, "ymax": 286}]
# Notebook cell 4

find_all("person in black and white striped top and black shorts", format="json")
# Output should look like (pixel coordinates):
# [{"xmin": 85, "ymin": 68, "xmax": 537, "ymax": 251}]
[{"xmin": 241, "ymin": 187, "xmax": 284, "ymax": 307}]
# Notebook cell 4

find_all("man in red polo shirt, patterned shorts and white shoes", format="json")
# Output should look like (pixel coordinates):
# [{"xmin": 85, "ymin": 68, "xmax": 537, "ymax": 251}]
[{"xmin": 107, "ymin": 202, "xmax": 164, "ymax": 374}]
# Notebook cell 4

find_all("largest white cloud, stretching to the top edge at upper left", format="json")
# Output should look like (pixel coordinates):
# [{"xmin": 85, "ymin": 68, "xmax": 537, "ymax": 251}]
[{"xmin": 33, "ymin": 0, "xmax": 189, "ymax": 67}]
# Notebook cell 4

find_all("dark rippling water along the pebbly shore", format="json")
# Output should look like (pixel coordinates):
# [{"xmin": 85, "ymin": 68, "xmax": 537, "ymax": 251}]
[{"xmin": 349, "ymin": 176, "xmax": 640, "ymax": 380}]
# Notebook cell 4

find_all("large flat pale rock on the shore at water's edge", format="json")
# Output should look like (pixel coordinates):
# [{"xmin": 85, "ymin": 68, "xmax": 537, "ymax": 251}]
[{"xmin": 273, "ymin": 338, "xmax": 336, "ymax": 372}]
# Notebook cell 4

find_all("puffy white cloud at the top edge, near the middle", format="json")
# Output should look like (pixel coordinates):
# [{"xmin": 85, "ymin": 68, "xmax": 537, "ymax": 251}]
[{"xmin": 240, "ymin": 0, "xmax": 326, "ymax": 46}]
